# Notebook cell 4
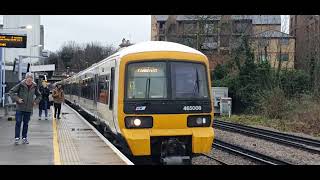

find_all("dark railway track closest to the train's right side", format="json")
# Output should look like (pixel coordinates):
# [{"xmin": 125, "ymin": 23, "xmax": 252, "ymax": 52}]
[{"xmin": 213, "ymin": 138, "xmax": 291, "ymax": 165}]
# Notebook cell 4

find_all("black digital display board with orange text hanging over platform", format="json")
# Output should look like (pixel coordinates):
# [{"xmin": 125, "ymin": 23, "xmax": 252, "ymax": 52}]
[{"xmin": 0, "ymin": 34, "xmax": 27, "ymax": 48}]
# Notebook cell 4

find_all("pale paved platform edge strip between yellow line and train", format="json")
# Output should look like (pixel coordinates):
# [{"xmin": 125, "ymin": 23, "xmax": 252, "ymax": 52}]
[{"xmin": 56, "ymin": 106, "xmax": 126, "ymax": 165}]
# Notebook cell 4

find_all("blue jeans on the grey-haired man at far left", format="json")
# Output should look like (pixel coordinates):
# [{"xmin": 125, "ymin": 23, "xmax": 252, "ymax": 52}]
[{"xmin": 15, "ymin": 111, "xmax": 31, "ymax": 138}]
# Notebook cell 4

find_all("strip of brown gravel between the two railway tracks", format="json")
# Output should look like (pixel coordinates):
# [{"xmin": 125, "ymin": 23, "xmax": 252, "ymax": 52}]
[{"xmin": 215, "ymin": 129, "xmax": 320, "ymax": 165}]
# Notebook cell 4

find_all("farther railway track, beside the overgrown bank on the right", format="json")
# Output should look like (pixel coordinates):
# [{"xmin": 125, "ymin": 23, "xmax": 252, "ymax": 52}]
[{"xmin": 213, "ymin": 120, "xmax": 320, "ymax": 154}]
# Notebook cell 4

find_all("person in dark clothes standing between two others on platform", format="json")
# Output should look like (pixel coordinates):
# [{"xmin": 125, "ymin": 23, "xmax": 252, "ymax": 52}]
[{"xmin": 39, "ymin": 82, "xmax": 50, "ymax": 120}]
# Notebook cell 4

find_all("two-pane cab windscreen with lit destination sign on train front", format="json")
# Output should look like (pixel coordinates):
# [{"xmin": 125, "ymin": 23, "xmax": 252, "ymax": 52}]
[{"xmin": 126, "ymin": 61, "xmax": 209, "ymax": 100}]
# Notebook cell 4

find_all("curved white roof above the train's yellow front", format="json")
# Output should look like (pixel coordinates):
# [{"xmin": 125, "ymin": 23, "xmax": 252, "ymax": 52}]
[{"xmin": 114, "ymin": 41, "xmax": 204, "ymax": 57}]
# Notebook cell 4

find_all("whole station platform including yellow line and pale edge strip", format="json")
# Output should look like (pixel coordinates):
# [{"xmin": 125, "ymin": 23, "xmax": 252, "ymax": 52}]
[{"xmin": 0, "ymin": 104, "xmax": 133, "ymax": 165}]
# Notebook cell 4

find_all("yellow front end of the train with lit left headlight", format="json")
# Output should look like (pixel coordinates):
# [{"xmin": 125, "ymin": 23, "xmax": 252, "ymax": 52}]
[{"xmin": 118, "ymin": 42, "xmax": 214, "ymax": 164}]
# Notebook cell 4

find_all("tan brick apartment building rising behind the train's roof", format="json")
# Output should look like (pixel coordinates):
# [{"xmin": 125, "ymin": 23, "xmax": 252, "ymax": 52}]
[{"xmin": 151, "ymin": 15, "xmax": 294, "ymax": 69}]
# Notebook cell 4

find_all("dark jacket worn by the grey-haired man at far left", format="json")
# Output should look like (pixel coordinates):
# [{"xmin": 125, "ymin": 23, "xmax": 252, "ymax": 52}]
[{"xmin": 9, "ymin": 80, "xmax": 41, "ymax": 112}]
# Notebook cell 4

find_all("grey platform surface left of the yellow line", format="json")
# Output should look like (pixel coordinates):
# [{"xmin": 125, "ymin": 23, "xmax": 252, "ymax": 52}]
[{"xmin": 0, "ymin": 109, "xmax": 53, "ymax": 165}]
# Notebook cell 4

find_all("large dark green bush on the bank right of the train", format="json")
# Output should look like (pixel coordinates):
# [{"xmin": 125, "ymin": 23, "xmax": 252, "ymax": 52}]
[{"xmin": 211, "ymin": 36, "xmax": 311, "ymax": 115}]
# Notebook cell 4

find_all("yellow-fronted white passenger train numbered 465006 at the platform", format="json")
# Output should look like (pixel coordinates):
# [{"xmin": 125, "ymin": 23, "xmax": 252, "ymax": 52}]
[{"xmin": 58, "ymin": 41, "xmax": 214, "ymax": 164}]
